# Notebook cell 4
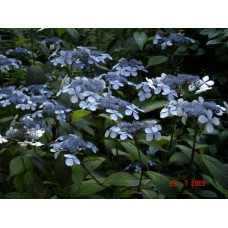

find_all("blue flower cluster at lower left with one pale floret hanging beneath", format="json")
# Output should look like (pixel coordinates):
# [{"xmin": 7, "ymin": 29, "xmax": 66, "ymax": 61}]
[{"xmin": 50, "ymin": 134, "xmax": 98, "ymax": 166}]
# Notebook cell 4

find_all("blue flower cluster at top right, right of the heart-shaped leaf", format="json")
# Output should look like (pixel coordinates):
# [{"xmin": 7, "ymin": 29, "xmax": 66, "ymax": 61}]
[{"xmin": 153, "ymin": 33, "xmax": 195, "ymax": 50}]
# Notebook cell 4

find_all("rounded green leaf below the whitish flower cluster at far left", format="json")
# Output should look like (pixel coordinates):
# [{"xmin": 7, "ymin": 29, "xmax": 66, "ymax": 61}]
[{"xmin": 9, "ymin": 156, "xmax": 32, "ymax": 177}]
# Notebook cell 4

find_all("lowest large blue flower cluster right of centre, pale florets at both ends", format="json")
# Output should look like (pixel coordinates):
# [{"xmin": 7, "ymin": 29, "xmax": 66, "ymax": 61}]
[{"xmin": 105, "ymin": 120, "xmax": 162, "ymax": 141}]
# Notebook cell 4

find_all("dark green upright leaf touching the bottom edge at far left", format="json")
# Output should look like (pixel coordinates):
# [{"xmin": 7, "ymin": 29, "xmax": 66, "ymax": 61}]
[{"xmin": 24, "ymin": 171, "xmax": 44, "ymax": 198}]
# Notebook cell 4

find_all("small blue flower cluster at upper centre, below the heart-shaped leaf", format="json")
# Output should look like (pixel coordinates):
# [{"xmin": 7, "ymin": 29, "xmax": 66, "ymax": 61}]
[{"xmin": 113, "ymin": 58, "xmax": 147, "ymax": 77}]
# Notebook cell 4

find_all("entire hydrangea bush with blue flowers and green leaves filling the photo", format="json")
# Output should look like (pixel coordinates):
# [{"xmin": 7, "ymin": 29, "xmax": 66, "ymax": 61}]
[{"xmin": 0, "ymin": 29, "xmax": 228, "ymax": 199}]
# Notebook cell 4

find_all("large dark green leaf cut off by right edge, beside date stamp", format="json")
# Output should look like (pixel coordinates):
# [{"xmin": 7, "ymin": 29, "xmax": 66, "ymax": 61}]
[{"xmin": 201, "ymin": 154, "xmax": 228, "ymax": 189}]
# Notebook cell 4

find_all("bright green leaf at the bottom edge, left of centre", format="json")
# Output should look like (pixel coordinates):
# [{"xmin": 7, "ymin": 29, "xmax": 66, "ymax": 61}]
[{"xmin": 76, "ymin": 179, "xmax": 105, "ymax": 197}]
